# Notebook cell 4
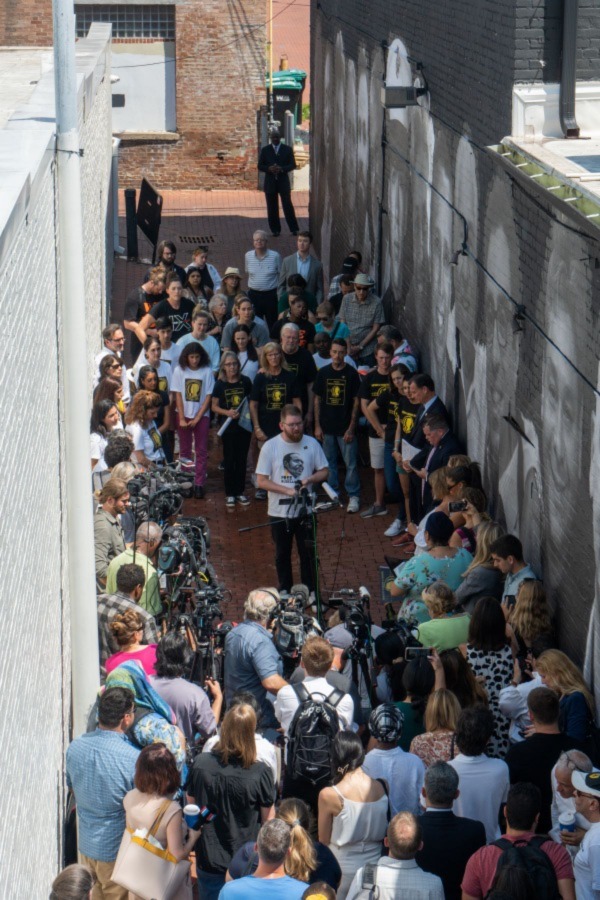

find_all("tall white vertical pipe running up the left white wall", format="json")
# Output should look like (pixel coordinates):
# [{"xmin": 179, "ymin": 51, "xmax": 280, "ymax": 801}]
[{"xmin": 52, "ymin": 0, "xmax": 100, "ymax": 736}]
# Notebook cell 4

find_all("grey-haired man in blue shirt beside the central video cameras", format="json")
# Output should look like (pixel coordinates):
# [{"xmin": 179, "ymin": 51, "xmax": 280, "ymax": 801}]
[{"xmin": 225, "ymin": 592, "xmax": 290, "ymax": 728}]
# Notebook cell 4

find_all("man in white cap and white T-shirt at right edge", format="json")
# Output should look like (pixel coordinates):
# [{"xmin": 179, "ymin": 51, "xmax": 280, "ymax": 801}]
[{"xmin": 571, "ymin": 770, "xmax": 600, "ymax": 900}]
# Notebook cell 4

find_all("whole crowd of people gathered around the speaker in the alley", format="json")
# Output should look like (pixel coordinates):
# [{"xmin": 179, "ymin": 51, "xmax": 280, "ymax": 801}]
[{"xmin": 51, "ymin": 231, "xmax": 600, "ymax": 900}]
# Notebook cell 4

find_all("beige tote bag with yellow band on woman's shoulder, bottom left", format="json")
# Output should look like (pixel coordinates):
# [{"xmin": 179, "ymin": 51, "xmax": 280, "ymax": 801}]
[{"xmin": 111, "ymin": 800, "xmax": 192, "ymax": 900}]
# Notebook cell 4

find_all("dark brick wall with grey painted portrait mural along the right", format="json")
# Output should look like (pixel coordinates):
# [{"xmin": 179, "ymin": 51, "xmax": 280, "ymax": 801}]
[{"xmin": 311, "ymin": 0, "xmax": 600, "ymax": 695}]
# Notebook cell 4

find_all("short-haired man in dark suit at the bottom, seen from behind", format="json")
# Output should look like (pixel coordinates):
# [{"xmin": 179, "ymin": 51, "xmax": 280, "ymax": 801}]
[{"xmin": 416, "ymin": 762, "xmax": 486, "ymax": 900}]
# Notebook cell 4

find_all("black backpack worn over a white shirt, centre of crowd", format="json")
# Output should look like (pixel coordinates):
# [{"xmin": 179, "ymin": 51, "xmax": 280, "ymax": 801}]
[{"xmin": 287, "ymin": 682, "xmax": 344, "ymax": 787}]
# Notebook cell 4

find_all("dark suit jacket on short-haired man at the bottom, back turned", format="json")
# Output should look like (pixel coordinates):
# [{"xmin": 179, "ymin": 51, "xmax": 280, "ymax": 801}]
[{"xmin": 416, "ymin": 810, "xmax": 485, "ymax": 900}]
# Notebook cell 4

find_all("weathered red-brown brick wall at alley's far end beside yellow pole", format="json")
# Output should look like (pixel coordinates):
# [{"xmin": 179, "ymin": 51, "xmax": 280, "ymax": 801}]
[{"xmin": 119, "ymin": 0, "xmax": 265, "ymax": 189}]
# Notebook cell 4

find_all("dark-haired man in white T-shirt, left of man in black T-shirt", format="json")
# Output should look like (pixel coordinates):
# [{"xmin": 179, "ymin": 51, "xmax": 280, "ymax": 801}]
[{"xmin": 450, "ymin": 706, "xmax": 510, "ymax": 844}]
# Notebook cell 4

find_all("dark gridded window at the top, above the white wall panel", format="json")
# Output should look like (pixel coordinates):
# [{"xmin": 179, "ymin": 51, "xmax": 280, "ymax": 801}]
[{"xmin": 75, "ymin": 3, "xmax": 175, "ymax": 41}]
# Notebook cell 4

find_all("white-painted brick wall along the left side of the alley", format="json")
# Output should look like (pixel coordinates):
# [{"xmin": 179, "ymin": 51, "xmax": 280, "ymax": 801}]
[{"xmin": 0, "ymin": 28, "xmax": 112, "ymax": 888}]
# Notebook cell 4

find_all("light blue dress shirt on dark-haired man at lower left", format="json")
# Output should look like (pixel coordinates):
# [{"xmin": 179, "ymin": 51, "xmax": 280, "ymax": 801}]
[{"xmin": 67, "ymin": 728, "xmax": 140, "ymax": 862}]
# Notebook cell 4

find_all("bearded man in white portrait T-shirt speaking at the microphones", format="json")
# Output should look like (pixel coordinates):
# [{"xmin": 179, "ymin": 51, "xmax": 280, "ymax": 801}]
[{"xmin": 256, "ymin": 404, "xmax": 329, "ymax": 591}]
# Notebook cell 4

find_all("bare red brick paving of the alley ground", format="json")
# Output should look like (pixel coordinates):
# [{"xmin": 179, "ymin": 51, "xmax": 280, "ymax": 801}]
[{"xmin": 112, "ymin": 191, "xmax": 391, "ymax": 617}]
